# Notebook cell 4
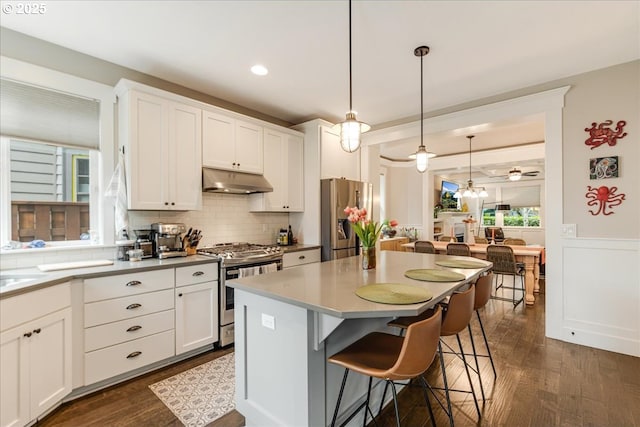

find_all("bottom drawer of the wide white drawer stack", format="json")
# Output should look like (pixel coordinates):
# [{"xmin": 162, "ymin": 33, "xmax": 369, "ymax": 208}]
[{"xmin": 84, "ymin": 330, "xmax": 175, "ymax": 385}]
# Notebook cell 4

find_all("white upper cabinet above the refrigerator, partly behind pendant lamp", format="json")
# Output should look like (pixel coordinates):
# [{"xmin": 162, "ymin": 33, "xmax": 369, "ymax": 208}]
[{"xmin": 320, "ymin": 126, "xmax": 360, "ymax": 181}]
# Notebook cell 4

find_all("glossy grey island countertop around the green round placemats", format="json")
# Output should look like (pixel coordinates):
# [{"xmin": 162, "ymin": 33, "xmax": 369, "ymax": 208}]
[{"xmin": 227, "ymin": 251, "xmax": 492, "ymax": 319}]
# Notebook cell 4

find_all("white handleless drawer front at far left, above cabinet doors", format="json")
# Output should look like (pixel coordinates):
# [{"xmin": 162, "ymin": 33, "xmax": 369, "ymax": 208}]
[{"xmin": 0, "ymin": 283, "xmax": 71, "ymax": 331}]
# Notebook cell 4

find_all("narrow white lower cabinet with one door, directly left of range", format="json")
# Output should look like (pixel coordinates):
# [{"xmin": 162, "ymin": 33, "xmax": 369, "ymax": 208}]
[{"xmin": 175, "ymin": 264, "xmax": 218, "ymax": 354}]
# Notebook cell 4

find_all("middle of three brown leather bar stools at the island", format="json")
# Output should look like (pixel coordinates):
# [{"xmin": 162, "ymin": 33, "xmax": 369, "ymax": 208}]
[{"xmin": 388, "ymin": 285, "xmax": 482, "ymax": 426}]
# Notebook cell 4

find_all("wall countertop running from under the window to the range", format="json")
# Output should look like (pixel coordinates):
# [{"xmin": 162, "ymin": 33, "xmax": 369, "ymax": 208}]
[{"xmin": 0, "ymin": 255, "xmax": 218, "ymax": 299}]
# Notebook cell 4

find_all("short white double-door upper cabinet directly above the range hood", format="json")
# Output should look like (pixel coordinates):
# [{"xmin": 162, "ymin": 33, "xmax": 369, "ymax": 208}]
[{"xmin": 202, "ymin": 110, "xmax": 264, "ymax": 175}]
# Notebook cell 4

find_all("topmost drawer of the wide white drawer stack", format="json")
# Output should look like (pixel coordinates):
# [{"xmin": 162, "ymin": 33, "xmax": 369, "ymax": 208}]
[{"xmin": 84, "ymin": 268, "xmax": 175, "ymax": 302}]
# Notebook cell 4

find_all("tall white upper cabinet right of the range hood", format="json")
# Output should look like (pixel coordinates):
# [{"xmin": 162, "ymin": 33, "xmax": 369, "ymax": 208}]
[{"xmin": 249, "ymin": 128, "xmax": 304, "ymax": 212}]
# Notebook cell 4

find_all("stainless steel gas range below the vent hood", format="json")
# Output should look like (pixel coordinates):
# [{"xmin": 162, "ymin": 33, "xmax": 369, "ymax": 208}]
[{"xmin": 198, "ymin": 243, "xmax": 282, "ymax": 347}]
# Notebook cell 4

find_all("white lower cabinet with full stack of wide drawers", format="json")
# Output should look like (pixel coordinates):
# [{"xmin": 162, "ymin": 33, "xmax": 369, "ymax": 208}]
[{"xmin": 84, "ymin": 269, "xmax": 175, "ymax": 385}]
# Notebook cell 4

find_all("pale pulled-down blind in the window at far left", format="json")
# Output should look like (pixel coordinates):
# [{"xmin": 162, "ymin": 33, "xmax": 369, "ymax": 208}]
[{"xmin": 0, "ymin": 79, "xmax": 100, "ymax": 149}]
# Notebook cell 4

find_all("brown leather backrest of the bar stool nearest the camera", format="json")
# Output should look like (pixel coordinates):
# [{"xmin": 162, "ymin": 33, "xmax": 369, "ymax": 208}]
[{"xmin": 386, "ymin": 306, "xmax": 442, "ymax": 380}]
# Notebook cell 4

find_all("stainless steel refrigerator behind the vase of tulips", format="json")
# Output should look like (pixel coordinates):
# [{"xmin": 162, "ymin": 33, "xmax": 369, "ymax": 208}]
[{"xmin": 320, "ymin": 178, "xmax": 373, "ymax": 261}]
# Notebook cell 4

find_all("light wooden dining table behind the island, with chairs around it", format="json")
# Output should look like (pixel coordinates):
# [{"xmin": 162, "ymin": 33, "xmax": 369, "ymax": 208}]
[{"xmin": 402, "ymin": 241, "xmax": 545, "ymax": 305}]
